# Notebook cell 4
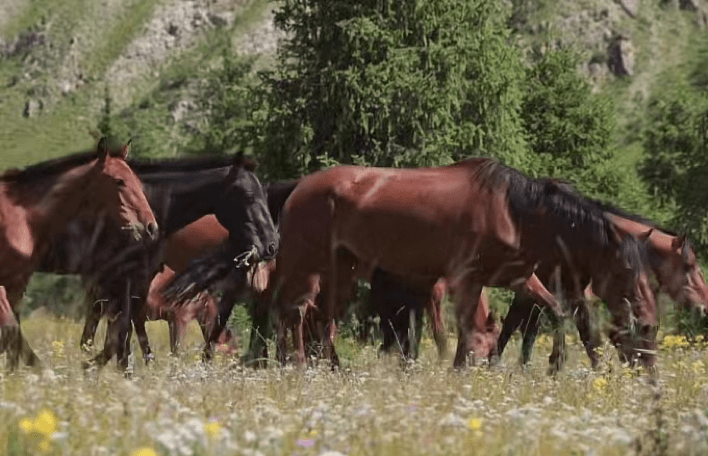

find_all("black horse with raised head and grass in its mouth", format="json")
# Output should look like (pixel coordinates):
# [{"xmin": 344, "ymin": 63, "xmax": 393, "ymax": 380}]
[{"xmin": 38, "ymin": 154, "xmax": 277, "ymax": 367}]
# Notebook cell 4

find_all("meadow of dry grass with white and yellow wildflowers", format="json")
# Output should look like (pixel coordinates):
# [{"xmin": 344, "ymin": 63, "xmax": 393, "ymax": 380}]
[{"xmin": 0, "ymin": 317, "xmax": 708, "ymax": 456}]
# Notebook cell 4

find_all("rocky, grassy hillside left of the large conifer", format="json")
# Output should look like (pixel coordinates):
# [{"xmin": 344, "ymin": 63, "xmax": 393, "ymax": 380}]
[{"xmin": 0, "ymin": 0, "xmax": 277, "ymax": 169}]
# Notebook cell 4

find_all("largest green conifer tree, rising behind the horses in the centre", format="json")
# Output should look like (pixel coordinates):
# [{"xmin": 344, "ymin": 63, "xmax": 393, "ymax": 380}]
[{"xmin": 252, "ymin": 0, "xmax": 526, "ymax": 178}]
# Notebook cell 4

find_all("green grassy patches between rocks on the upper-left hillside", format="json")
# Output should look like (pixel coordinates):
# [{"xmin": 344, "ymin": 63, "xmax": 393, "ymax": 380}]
[{"xmin": 0, "ymin": 0, "xmax": 267, "ymax": 169}]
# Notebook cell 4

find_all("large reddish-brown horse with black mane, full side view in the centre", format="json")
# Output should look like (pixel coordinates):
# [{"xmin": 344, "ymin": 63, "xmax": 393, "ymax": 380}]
[{"xmin": 277, "ymin": 159, "xmax": 660, "ymax": 366}]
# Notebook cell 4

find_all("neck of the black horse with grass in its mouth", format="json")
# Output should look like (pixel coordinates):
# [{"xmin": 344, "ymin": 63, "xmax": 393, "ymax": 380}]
[{"xmin": 139, "ymin": 167, "xmax": 231, "ymax": 235}]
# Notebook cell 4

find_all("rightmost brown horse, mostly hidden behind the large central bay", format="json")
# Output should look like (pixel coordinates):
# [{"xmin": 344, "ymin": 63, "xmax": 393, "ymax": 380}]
[{"xmin": 498, "ymin": 201, "xmax": 708, "ymax": 368}]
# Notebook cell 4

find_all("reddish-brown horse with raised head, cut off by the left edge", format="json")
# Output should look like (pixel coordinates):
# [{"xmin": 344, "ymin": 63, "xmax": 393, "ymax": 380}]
[{"xmin": 0, "ymin": 138, "xmax": 158, "ymax": 368}]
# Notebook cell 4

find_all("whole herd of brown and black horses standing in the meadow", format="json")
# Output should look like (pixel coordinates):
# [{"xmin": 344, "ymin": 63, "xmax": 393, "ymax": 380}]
[{"xmin": 0, "ymin": 138, "xmax": 708, "ymax": 378}]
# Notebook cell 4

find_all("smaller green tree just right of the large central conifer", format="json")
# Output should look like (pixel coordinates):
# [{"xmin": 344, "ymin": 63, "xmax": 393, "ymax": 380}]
[{"xmin": 521, "ymin": 49, "xmax": 623, "ymax": 200}]
